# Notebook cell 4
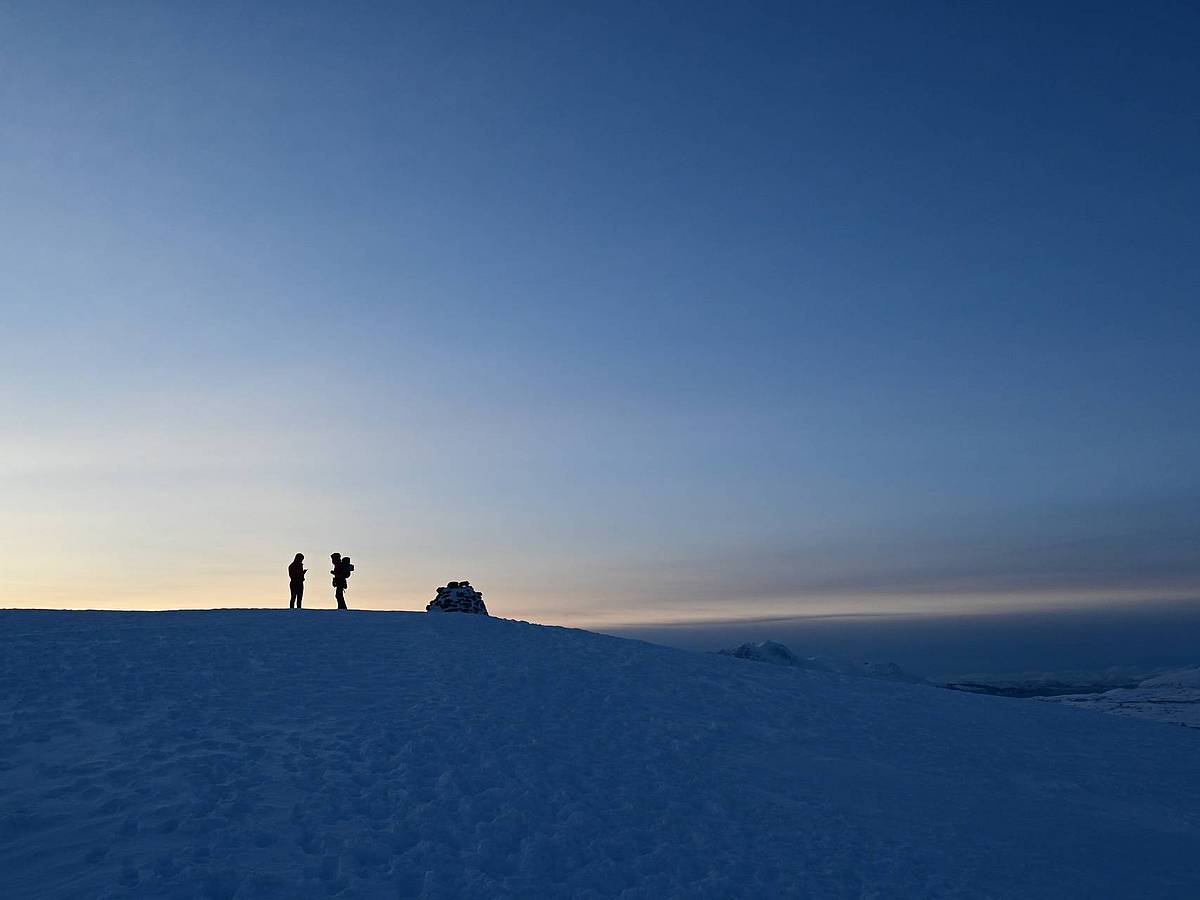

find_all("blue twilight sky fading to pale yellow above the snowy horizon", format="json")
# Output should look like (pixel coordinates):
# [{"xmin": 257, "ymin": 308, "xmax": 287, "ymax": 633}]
[{"xmin": 0, "ymin": 2, "xmax": 1200, "ymax": 648}]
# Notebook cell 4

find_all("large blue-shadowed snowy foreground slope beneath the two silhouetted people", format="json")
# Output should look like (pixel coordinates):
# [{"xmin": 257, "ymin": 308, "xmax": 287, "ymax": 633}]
[{"xmin": 0, "ymin": 610, "xmax": 1200, "ymax": 900}]
